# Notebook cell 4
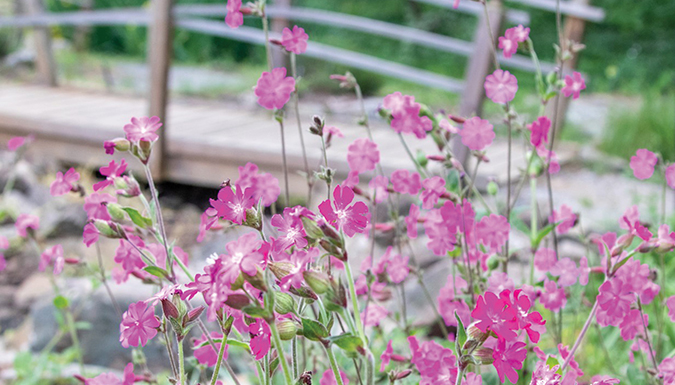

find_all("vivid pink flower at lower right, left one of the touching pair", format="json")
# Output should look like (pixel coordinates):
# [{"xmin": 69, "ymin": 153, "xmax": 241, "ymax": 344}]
[{"xmin": 471, "ymin": 292, "xmax": 518, "ymax": 341}]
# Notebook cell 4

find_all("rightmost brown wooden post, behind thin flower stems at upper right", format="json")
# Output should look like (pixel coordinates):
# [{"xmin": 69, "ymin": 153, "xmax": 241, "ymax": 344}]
[{"xmin": 546, "ymin": 0, "xmax": 590, "ymax": 138}]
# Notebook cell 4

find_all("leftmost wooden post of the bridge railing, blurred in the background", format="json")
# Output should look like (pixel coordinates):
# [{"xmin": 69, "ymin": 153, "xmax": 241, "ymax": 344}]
[{"xmin": 24, "ymin": 0, "xmax": 57, "ymax": 87}]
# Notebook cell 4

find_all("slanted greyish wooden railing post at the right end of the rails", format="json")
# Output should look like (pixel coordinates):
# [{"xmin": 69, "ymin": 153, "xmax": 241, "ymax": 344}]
[{"xmin": 452, "ymin": 0, "xmax": 504, "ymax": 167}]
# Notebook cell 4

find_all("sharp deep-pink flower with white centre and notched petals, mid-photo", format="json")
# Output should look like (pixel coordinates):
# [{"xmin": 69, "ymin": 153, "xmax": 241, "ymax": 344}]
[{"xmin": 319, "ymin": 185, "xmax": 370, "ymax": 238}]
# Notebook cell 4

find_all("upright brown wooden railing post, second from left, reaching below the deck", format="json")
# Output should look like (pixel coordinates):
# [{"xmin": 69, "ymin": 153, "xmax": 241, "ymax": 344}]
[{"xmin": 148, "ymin": 0, "xmax": 173, "ymax": 180}]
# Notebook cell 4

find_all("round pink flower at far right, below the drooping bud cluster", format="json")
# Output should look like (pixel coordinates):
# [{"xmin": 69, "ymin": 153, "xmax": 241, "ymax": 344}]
[{"xmin": 598, "ymin": 277, "xmax": 635, "ymax": 326}]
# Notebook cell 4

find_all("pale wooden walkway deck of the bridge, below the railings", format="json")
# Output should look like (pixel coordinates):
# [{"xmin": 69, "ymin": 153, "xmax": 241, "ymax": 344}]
[{"xmin": 0, "ymin": 83, "xmax": 540, "ymax": 193}]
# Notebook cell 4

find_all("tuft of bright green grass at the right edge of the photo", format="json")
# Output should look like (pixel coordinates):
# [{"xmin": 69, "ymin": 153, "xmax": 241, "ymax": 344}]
[{"xmin": 600, "ymin": 92, "xmax": 675, "ymax": 161}]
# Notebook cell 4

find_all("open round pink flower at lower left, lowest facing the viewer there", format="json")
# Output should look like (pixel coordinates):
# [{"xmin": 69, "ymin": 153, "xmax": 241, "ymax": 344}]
[{"xmin": 120, "ymin": 301, "xmax": 160, "ymax": 348}]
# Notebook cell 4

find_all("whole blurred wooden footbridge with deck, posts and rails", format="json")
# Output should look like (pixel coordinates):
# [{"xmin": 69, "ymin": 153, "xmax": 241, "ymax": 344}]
[{"xmin": 0, "ymin": 0, "xmax": 604, "ymax": 189}]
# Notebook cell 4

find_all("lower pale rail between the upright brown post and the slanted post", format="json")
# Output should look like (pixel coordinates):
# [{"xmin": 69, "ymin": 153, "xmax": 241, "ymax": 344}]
[{"xmin": 176, "ymin": 19, "xmax": 464, "ymax": 92}]
